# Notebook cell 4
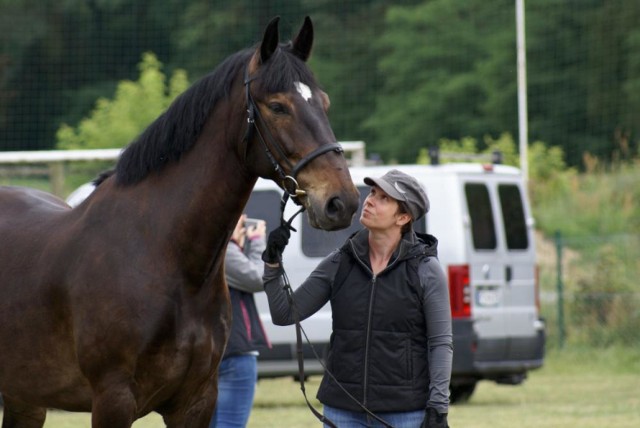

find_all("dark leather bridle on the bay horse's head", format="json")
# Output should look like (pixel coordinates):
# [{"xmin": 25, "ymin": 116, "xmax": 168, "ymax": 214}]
[{"xmin": 242, "ymin": 65, "xmax": 344, "ymax": 220}]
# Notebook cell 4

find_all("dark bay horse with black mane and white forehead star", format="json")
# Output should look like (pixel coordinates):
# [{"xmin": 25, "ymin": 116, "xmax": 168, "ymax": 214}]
[{"xmin": 0, "ymin": 18, "xmax": 358, "ymax": 428}]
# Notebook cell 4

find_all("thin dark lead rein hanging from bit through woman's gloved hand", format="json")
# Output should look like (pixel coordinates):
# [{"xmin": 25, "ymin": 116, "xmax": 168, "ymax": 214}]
[{"xmin": 280, "ymin": 196, "xmax": 393, "ymax": 428}]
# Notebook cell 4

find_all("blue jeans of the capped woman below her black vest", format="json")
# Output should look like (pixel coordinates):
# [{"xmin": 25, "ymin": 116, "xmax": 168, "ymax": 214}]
[{"xmin": 323, "ymin": 405, "xmax": 425, "ymax": 428}]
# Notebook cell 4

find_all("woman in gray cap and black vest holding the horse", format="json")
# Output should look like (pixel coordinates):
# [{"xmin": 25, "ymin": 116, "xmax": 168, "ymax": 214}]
[{"xmin": 262, "ymin": 170, "xmax": 453, "ymax": 428}]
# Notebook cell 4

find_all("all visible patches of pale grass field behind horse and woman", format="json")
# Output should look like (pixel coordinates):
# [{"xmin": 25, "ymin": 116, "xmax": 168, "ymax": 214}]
[{"xmin": 2, "ymin": 349, "xmax": 640, "ymax": 428}]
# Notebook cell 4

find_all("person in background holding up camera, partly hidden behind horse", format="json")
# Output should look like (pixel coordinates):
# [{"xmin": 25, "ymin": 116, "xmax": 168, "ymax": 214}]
[{"xmin": 209, "ymin": 214, "xmax": 270, "ymax": 428}]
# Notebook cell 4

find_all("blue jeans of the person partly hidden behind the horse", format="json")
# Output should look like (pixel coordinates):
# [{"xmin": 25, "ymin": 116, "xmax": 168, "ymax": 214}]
[{"xmin": 209, "ymin": 355, "xmax": 258, "ymax": 428}]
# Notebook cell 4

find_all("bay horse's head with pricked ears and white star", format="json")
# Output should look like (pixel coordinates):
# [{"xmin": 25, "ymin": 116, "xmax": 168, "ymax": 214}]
[{"xmin": 241, "ymin": 17, "xmax": 359, "ymax": 230}]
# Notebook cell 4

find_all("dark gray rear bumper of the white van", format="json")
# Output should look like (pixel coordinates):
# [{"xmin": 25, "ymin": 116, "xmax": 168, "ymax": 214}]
[{"xmin": 452, "ymin": 319, "xmax": 546, "ymax": 385}]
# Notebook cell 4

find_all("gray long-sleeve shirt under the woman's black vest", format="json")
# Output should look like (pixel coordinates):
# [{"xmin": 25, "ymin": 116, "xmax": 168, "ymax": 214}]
[{"xmin": 263, "ymin": 234, "xmax": 453, "ymax": 413}]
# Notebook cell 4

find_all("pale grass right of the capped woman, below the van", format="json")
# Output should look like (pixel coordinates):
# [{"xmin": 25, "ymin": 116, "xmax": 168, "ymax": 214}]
[{"xmin": 450, "ymin": 350, "xmax": 640, "ymax": 428}]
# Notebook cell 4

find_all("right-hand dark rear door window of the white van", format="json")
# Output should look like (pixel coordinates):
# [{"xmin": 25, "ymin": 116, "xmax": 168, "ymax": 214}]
[{"xmin": 498, "ymin": 184, "xmax": 529, "ymax": 250}]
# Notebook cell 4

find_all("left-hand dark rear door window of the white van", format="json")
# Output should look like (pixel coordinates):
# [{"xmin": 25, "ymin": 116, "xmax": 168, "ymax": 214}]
[{"xmin": 464, "ymin": 183, "xmax": 497, "ymax": 250}]
